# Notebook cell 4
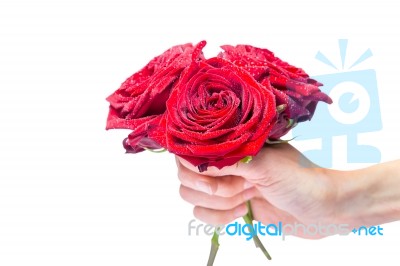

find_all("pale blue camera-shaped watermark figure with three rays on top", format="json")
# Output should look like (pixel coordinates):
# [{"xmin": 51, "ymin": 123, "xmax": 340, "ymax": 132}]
[{"xmin": 292, "ymin": 39, "xmax": 382, "ymax": 167}]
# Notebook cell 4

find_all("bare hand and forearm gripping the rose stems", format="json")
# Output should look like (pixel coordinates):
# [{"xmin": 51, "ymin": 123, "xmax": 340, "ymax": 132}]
[{"xmin": 176, "ymin": 144, "xmax": 400, "ymax": 238}]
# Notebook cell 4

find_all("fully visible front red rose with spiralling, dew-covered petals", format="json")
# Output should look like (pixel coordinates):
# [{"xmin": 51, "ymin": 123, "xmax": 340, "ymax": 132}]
[{"xmin": 152, "ymin": 42, "xmax": 276, "ymax": 171}]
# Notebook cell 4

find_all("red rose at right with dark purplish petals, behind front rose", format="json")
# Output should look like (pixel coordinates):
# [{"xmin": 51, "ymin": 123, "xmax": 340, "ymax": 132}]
[{"xmin": 219, "ymin": 45, "xmax": 332, "ymax": 139}]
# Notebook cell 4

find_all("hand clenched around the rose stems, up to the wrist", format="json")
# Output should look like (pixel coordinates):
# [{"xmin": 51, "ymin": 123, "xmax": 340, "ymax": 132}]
[{"xmin": 177, "ymin": 144, "xmax": 337, "ymax": 238}]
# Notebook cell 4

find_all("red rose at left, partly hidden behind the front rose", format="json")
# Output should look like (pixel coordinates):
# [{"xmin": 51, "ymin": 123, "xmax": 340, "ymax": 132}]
[{"xmin": 106, "ymin": 44, "xmax": 203, "ymax": 153}]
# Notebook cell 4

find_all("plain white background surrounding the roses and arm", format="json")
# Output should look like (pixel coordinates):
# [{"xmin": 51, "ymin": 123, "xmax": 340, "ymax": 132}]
[{"xmin": 0, "ymin": 0, "xmax": 400, "ymax": 266}]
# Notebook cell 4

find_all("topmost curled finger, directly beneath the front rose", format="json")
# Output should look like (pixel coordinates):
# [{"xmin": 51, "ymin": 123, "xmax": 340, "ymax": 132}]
[{"xmin": 177, "ymin": 160, "xmax": 253, "ymax": 197}]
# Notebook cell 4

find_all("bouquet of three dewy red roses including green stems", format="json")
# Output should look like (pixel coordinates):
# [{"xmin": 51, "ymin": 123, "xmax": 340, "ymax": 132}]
[{"xmin": 106, "ymin": 41, "xmax": 331, "ymax": 265}]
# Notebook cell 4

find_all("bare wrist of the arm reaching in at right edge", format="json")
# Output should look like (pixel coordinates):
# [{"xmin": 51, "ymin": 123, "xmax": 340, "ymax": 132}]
[{"xmin": 329, "ymin": 165, "xmax": 400, "ymax": 227}]
